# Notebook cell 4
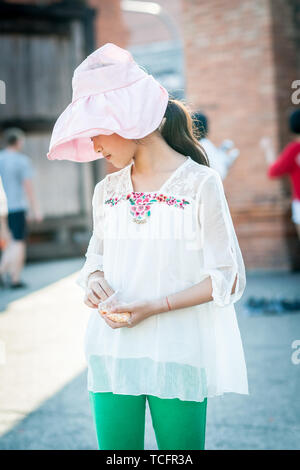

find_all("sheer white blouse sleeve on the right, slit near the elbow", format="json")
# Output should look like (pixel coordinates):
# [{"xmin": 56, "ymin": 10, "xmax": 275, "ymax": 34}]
[{"xmin": 199, "ymin": 171, "xmax": 246, "ymax": 307}]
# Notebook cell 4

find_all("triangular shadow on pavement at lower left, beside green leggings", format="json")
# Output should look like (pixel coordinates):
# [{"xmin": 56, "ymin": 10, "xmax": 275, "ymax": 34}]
[{"xmin": 0, "ymin": 371, "xmax": 97, "ymax": 450}]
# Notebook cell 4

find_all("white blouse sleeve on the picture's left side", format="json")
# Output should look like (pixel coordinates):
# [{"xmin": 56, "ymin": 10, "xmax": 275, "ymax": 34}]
[{"xmin": 76, "ymin": 180, "xmax": 104, "ymax": 290}]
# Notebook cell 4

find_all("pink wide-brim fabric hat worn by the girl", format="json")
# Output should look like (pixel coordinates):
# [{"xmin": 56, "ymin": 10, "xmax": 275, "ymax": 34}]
[{"xmin": 47, "ymin": 43, "xmax": 169, "ymax": 162}]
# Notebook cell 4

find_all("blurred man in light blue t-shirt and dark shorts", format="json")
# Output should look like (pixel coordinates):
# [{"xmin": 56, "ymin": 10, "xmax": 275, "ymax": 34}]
[{"xmin": 0, "ymin": 127, "xmax": 42, "ymax": 288}]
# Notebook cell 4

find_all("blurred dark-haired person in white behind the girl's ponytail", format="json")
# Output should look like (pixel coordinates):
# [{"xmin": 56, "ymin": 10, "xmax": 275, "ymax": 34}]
[{"xmin": 192, "ymin": 112, "xmax": 240, "ymax": 180}]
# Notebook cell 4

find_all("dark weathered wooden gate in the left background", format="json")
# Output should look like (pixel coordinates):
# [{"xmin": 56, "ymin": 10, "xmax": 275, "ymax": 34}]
[{"xmin": 0, "ymin": 1, "xmax": 96, "ymax": 259}]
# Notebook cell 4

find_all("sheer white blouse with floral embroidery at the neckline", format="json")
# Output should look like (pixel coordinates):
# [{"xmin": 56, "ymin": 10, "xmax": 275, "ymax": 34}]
[{"xmin": 76, "ymin": 156, "xmax": 249, "ymax": 401}]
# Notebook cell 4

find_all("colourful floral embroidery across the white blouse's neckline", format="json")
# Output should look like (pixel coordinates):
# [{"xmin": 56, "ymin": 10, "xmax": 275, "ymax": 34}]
[{"xmin": 105, "ymin": 191, "xmax": 190, "ymax": 224}]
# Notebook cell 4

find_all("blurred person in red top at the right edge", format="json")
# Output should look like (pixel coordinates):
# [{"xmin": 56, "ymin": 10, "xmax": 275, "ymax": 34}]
[{"xmin": 261, "ymin": 109, "xmax": 300, "ymax": 240}]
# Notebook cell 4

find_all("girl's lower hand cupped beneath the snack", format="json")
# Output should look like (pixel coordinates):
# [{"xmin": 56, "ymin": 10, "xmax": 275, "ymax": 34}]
[{"xmin": 99, "ymin": 301, "xmax": 157, "ymax": 329}]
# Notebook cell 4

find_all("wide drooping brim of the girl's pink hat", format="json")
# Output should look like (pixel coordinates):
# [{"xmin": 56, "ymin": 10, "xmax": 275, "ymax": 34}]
[{"xmin": 47, "ymin": 75, "xmax": 169, "ymax": 162}]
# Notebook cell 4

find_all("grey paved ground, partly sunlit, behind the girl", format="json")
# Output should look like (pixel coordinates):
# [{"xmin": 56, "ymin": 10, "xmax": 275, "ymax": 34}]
[{"xmin": 0, "ymin": 259, "xmax": 300, "ymax": 450}]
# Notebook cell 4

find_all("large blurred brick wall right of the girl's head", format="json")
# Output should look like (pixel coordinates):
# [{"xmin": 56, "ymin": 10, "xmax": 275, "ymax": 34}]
[{"xmin": 183, "ymin": 0, "xmax": 299, "ymax": 269}]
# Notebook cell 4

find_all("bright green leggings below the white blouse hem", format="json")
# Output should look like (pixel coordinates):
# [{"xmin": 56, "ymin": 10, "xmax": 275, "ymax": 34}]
[{"xmin": 89, "ymin": 391, "xmax": 207, "ymax": 450}]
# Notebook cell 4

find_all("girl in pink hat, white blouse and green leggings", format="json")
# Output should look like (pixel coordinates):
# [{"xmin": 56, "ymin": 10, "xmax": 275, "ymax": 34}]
[{"xmin": 48, "ymin": 43, "xmax": 248, "ymax": 450}]
